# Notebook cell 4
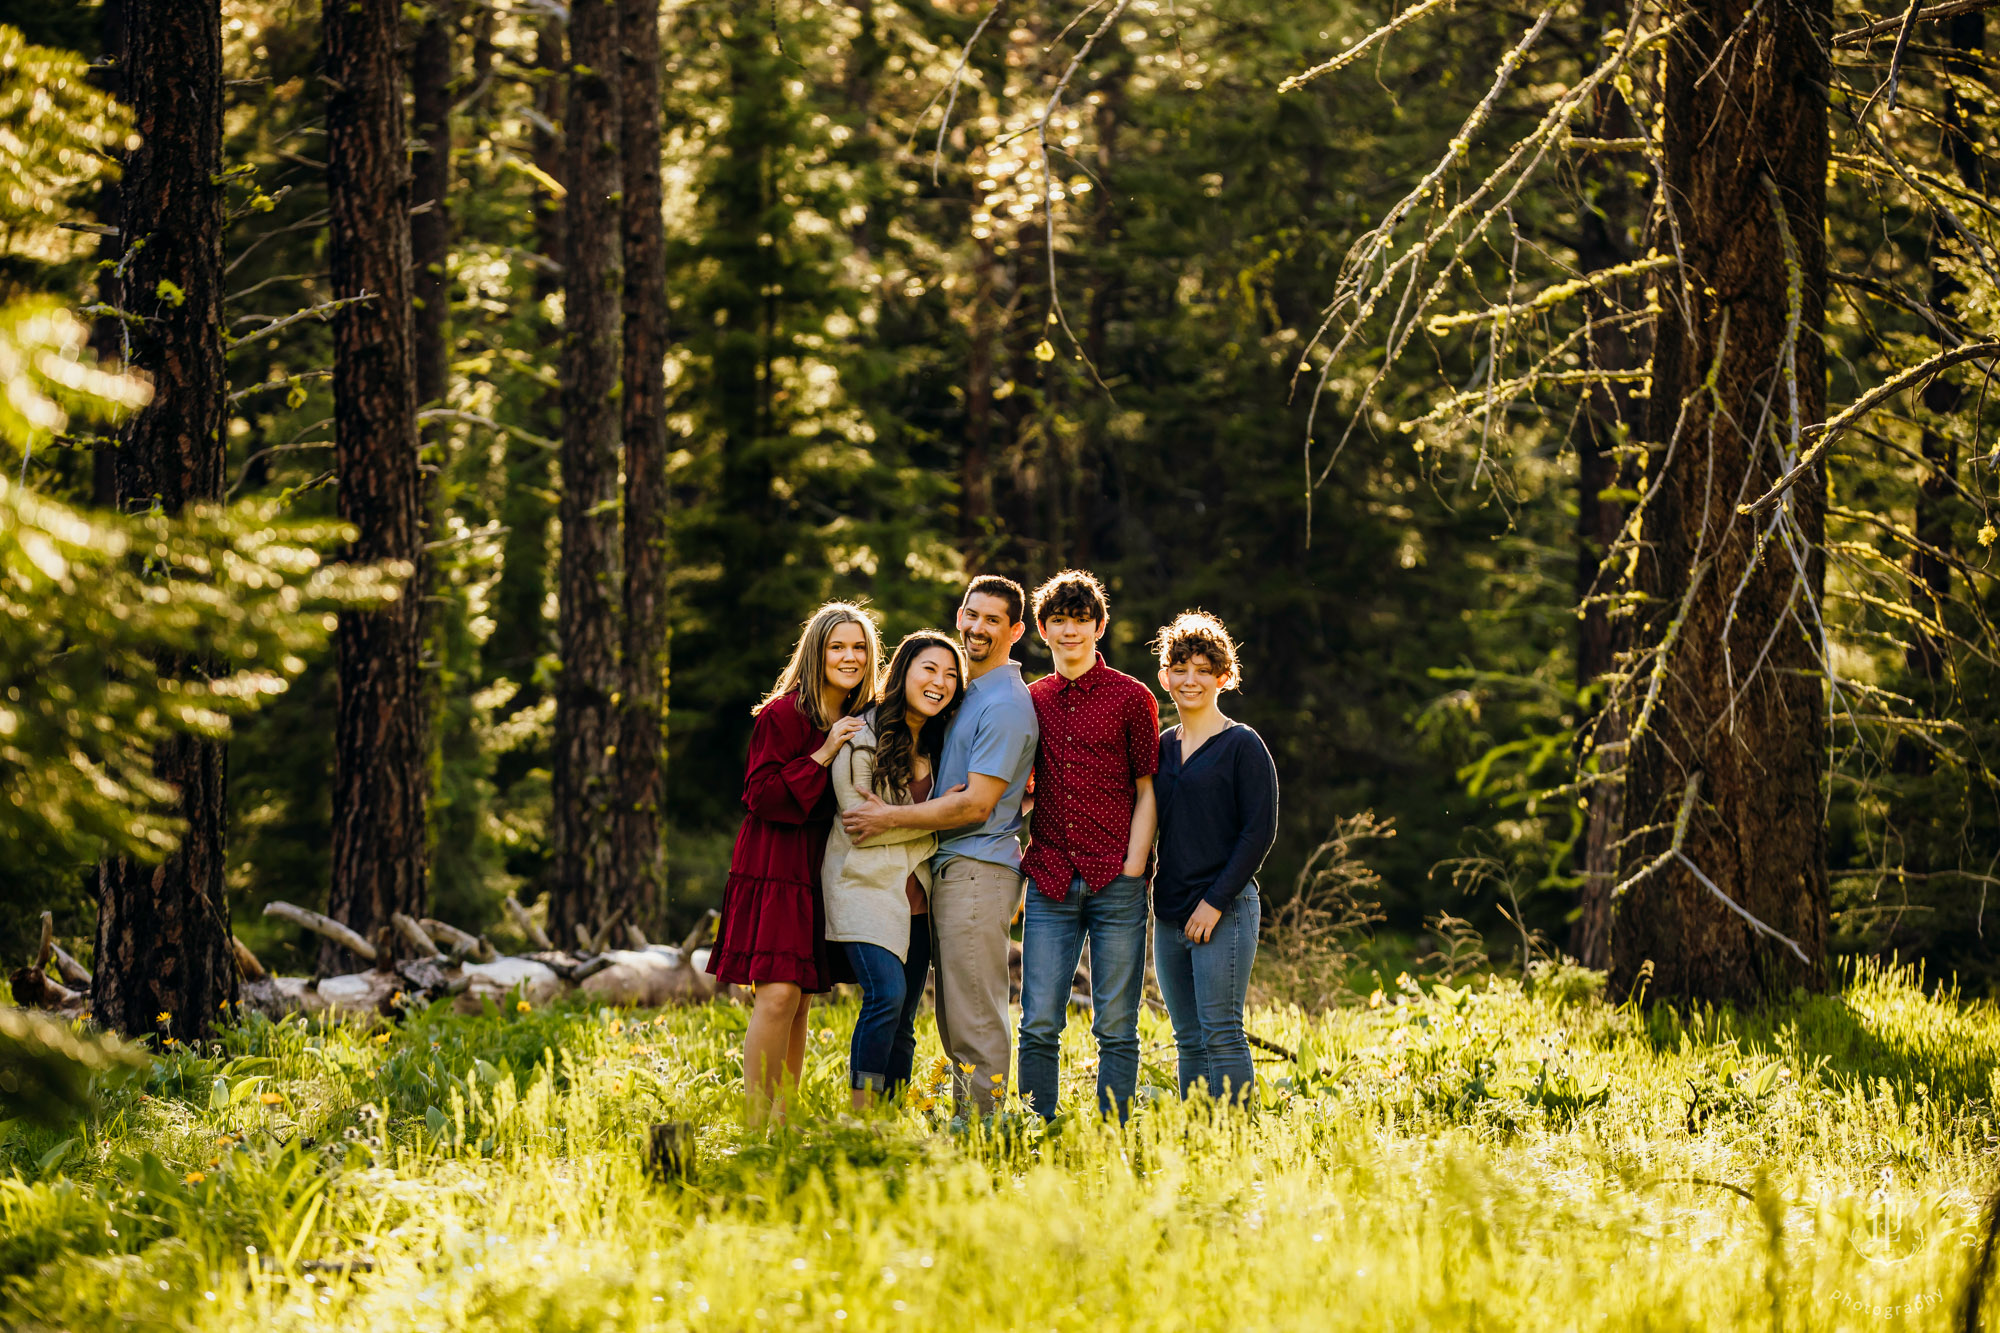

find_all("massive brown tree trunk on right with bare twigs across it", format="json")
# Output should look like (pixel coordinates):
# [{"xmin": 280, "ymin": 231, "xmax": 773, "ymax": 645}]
[{"xmin": 1612, "ymin": 0, "xmax": 1832, "ymax": 1001}]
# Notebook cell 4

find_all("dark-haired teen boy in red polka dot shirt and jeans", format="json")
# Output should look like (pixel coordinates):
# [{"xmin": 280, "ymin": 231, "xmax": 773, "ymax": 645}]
[{"xmin": 1020, "ymin": 568, "xmax": 1160, "ymax": 1119}]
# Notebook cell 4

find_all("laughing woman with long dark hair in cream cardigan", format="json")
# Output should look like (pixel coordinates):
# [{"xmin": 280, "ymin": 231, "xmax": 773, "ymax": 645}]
[{"xmin": 820, "ymin": 630, "xmax": 966, "ymax": 1111}]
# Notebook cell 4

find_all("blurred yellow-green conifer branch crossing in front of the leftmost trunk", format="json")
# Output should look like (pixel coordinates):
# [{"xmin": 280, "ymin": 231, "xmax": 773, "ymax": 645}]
[{"xmin": 0, "ymin": 478, "xmax": 396, "ymax": 861}]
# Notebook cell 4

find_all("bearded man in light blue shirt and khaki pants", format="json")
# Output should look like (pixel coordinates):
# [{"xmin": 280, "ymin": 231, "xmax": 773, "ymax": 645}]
[{"xmin": 840, "ymin": 574, "xmax": 1040, "ymax": 1115}]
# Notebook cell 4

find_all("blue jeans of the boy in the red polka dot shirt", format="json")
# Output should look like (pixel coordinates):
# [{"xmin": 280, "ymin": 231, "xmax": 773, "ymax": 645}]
[{"xmin": 1020, "ymin": 875, "xmax": 1146, "ymax": 1119}]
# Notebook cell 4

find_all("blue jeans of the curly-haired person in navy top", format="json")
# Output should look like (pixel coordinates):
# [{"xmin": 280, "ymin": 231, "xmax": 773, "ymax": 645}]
[{"xmin": 1152, "ymin": 885, "xmax": 1264, "ymax": 1101}]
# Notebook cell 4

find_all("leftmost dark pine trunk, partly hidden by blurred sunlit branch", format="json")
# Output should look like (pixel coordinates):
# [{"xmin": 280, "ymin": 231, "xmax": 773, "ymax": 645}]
[{"xmin": 92, "ymin": 0, "xmax": 236, "ymax": 1039}]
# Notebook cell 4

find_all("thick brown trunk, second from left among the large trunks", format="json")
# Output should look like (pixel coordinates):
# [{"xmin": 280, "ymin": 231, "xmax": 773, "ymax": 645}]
[{"xmin": 320, "ymin": 0, "xmax": 430, "ymax": 971}]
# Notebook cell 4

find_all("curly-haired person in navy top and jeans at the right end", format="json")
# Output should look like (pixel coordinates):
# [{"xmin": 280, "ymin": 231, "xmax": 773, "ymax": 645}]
[{"xmin": 1152, "ymin": 610, "xmax": 1278, "ymax": 1101}]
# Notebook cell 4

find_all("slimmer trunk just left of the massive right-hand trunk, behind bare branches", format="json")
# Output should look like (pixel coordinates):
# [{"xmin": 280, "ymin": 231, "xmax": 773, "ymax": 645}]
[{"xmin": 1570, "ymin": 0, "xmax": 1648, "ymax": 969}]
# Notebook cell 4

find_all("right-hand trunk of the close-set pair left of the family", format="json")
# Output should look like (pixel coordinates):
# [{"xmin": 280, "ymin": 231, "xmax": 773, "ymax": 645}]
[{"xmin": 612, "ymin": 0, "xmax": 668, "ymax": 925}]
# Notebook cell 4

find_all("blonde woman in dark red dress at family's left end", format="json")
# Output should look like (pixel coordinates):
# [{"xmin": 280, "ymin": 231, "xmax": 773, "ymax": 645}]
[{"xmin": 708, "ymin": 602, "xmax": 882, "ymax": 1125}]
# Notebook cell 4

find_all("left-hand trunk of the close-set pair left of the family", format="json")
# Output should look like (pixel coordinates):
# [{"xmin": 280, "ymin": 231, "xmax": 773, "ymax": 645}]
[{"xmin": 548, "ymin": 0, "xmax": 624, "ymax": 932}]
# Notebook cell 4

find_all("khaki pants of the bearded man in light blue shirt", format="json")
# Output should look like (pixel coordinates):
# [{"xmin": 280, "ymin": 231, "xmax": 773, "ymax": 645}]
[{"xmin": 930, "ymin": 857, "xmax": 1022, "ymax": 1115}]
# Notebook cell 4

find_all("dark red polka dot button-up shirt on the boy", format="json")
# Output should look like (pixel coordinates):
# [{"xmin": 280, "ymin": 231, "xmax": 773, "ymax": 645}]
[{"xmin": 1020, "ymin": 652, "xmax": 1160, "ymax": 903}]
